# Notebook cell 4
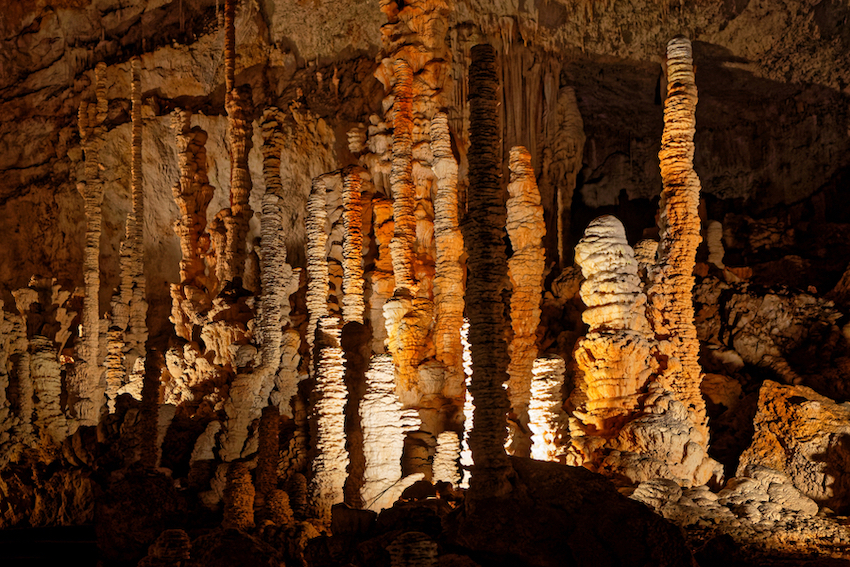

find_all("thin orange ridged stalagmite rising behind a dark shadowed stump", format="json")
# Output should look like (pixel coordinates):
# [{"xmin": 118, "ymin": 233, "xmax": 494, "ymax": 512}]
[{"xmin": 342, "ymin": 167, "xmax": 365, "ymax": 323}]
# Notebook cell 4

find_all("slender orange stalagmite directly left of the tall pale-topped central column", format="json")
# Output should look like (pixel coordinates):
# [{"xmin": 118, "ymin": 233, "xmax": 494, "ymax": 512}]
[{"xmin": 390, "ymin": 59, "xmax": 416, "ymax": 296}]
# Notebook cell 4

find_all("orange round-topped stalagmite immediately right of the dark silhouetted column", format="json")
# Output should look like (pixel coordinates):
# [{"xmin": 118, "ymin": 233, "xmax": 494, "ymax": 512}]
[{"xmin": 507, "ymin": 146, "xmax": 546, "ymax": 457}]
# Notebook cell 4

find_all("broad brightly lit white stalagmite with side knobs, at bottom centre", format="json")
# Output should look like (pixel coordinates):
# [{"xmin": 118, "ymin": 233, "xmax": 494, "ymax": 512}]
[{"xmin": 360, "ymin": 355, "xmax": 423, "ymax": 511}]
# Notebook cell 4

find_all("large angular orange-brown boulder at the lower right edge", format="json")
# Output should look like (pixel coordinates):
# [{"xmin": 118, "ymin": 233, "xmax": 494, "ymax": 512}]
[{"xmin": 738, "ymin": 380, "xmax": 850, "ymax": 510}]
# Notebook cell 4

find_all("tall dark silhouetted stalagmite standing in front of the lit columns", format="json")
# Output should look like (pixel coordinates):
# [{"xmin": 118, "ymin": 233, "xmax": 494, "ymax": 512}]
[{"xmin": 464, "ymin": 44, "xmax": 512, "ymax": 498}]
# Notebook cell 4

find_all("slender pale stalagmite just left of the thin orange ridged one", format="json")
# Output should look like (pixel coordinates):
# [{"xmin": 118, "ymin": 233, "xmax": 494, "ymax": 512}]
[{"xmin": 304, "ymin": 177, "xmax": 330, "ymax": 356}]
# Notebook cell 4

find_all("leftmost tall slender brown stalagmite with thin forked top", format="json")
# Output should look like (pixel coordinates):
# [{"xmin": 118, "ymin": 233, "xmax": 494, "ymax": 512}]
[{"xmin": 75, "ymin": 62, "xmax": 109, "ymax": 425}]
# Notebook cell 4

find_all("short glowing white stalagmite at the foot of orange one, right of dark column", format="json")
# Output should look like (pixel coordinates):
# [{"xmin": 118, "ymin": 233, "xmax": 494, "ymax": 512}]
[{"xmin": 528, "ymin": 356, "xmax": 569, "ymax": 462}]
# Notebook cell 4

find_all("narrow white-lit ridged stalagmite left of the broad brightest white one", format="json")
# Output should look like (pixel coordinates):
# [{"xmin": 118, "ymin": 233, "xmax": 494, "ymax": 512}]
[{"xmin": 309, "ymin": 317, "xmax": 348, "ymax": 521}]
